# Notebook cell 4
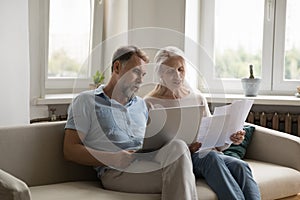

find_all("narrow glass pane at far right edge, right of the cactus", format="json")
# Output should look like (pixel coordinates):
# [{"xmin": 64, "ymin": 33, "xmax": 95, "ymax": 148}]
[{"xmin": 285, "ymin": 0, "xmax": 300, "ymax": 80}]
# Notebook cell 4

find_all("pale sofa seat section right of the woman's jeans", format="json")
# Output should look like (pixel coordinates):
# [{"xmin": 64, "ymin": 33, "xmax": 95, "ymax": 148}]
[{"xmin": 246, "ymin": 160, "xmax": 300, "ymax": 199}]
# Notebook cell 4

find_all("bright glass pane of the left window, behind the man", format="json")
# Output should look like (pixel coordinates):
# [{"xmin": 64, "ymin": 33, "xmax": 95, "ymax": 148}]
[{"xmin": 48, "ymin": 0, "xmax": 91, "ymax": 78}]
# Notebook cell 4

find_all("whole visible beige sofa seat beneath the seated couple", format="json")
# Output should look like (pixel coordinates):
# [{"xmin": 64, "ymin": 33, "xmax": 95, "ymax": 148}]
[{"xmin": 30, "ymin": 160, "xmax": 300, "ymax": 200}]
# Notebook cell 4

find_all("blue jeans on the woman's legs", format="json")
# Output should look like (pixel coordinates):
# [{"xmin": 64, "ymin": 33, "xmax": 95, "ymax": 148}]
[{"xmin": 192, "ymin": 150, "xmax": 261, "ymax": 200}]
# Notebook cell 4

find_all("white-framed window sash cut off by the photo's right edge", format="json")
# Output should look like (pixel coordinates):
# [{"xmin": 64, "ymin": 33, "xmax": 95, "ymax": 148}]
[{"xmin": 274, "ymin": 0, "xmax": 300, "ymax": 90}]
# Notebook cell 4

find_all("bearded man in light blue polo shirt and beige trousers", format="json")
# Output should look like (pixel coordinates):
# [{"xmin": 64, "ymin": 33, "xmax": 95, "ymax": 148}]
[{"xmin": 64, "ymin": 46, "xmax": 198, "ymax": 200}]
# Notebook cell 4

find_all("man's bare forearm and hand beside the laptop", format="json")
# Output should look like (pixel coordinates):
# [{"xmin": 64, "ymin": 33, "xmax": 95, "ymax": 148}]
[{"xmin": 63, "ymin": 129, "xmax": 134, "ymax": 168}]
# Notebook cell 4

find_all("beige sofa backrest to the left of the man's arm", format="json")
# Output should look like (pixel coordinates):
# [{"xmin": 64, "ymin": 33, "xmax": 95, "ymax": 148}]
[{"xmin": 0, "ymin": 121, "xmax": 97, "ymax": 186}]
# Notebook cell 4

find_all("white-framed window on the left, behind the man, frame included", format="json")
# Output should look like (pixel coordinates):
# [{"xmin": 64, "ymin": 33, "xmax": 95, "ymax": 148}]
[{"xmin": 39, "ymin": 0, "xmax": 103, "ymax": 94}]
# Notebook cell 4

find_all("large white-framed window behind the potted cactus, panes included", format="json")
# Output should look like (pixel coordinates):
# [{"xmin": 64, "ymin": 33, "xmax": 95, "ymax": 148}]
[{"xmin": 195, "ymin": 0, "xmax": 300, "ymax": 95}]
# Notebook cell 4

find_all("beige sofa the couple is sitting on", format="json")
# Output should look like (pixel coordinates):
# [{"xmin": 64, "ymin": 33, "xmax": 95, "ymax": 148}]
[{"xmin": 0, "ymin": 122, "xmax": 300, "ymax": 200}]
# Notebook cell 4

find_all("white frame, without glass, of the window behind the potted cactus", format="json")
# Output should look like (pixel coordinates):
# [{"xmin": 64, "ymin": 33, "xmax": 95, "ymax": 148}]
[{"xmin": 199, "ymin": 0, "xmax": 300, "ymax": 95}]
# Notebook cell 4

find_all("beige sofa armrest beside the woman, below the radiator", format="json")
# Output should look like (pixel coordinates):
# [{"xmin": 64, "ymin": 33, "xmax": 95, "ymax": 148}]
[{"xmin": 245, "ymin": 124, "xmax": 300, "ymax": 171}]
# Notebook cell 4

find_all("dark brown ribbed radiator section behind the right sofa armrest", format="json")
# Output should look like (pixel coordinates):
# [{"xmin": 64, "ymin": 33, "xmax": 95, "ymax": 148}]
[{"xmin": 246, "ymin": 111, "xmax": 300, "ymax": 136}]
